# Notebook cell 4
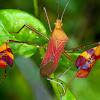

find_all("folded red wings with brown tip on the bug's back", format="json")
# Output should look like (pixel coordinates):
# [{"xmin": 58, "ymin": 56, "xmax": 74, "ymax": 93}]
[{"xmin": 40, "ymin": 37, "xmax": 67, "ymax": 77}]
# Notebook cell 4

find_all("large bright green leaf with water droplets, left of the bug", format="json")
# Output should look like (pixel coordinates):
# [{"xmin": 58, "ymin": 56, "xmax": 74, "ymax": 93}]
[{"xmin": 0, "ymin": 9, "xmax": 47, "ymax": 57}]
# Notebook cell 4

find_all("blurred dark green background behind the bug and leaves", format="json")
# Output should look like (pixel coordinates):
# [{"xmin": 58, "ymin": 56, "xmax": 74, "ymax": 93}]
[{"xmin": 0, "ymin": 0, "xmax": 100, "ymax": 100}]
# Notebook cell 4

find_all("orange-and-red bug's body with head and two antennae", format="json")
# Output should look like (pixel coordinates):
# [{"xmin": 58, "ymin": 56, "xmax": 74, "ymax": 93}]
[{"xmin": 40, "ymin": 0, "xmax": 74, "ymax": 78}]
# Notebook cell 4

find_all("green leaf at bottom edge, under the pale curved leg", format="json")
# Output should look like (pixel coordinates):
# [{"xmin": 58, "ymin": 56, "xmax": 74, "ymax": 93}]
[{"xmin": 48, "ymin": 78, "xmax": 76, "ymax": 100}]
